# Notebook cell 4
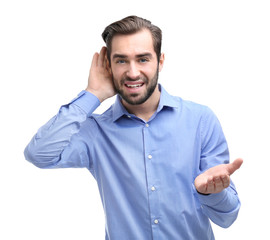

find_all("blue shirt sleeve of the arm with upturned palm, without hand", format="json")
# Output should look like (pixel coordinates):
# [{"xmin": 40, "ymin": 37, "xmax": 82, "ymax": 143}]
[{"xmin": 198, "ymin": 107, "xmax": 240, "ymax": 228}]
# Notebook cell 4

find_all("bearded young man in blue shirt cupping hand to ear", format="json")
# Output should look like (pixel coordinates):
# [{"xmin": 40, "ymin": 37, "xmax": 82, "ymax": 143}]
[{"xmin": 25, "ymin": 16, "xmax": 242, "ymax": 240}]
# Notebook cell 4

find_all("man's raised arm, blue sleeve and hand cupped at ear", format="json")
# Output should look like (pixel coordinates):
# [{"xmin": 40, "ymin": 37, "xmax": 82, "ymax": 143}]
[{"xmin": 24, "ymin": 47, "xmax": 115, "ymax": 168}]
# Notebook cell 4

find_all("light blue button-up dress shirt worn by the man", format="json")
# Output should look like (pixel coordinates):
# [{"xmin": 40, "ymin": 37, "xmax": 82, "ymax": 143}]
[{"xmin": 25, "ymin": 86, "xmax": 240, "ymax": 240}]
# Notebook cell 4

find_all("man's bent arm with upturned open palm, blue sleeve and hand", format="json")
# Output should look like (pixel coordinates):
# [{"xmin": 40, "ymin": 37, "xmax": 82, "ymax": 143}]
[{"xmin": 194, "ymin": 109, "xmax": 243, "ymax": 228}]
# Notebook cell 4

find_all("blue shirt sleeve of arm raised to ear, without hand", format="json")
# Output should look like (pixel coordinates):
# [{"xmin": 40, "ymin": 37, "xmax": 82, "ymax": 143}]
[{"xmin": 24, "ymin": 91, "xmax": 100, "ymax": 168}]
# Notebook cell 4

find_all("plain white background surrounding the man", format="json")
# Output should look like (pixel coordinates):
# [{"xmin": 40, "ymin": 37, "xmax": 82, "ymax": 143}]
[{"xmin": 0, "ymin": 0, "xmax": 270, "ymax": 240}]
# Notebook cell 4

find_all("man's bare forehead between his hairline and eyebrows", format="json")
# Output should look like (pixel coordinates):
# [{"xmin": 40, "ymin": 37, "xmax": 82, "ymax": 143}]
[{"xmin": 111, "ymin": 29, "xmax": 154, "ymax": 55}]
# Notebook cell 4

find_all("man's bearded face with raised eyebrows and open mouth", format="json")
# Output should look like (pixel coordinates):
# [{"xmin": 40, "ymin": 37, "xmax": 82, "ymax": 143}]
[{"xmin": 111, "ymin": 30, "xmax": 163, "ymax": 105}]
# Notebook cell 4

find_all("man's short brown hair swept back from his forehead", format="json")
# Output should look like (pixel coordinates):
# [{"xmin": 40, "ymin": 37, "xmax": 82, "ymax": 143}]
[{"xmin": 102, "ymin": 16, "xmax": 162, "ymax": 62}]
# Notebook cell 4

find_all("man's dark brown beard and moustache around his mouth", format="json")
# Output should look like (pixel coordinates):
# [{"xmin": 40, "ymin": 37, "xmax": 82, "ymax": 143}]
[{"xmin": 112, "ymin": 68, "xmax": 159, "ymax": 105}]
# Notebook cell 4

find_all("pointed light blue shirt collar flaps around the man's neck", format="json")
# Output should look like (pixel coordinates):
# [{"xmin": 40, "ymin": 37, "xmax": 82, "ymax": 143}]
[{"xmin": 112, "ymin": 84, "xmax": 179, "ymax": 122}]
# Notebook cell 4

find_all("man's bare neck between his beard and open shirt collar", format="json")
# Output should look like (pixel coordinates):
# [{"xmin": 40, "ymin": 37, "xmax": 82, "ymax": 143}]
[{"xmin": 122, "ymin": 85, "xmax": 160, "ymax": 122}]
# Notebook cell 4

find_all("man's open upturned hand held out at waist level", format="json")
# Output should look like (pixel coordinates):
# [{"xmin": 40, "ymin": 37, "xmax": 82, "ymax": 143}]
[{"xmin": 194, "ymin": 158, "xmax": 243, "ymax": 194}]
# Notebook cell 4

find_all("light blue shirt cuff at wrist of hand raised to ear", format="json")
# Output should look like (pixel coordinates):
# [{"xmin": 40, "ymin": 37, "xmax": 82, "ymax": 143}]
[{"xmin": 70, "ymin": 90, "xmax": 100, "ymax": 116}]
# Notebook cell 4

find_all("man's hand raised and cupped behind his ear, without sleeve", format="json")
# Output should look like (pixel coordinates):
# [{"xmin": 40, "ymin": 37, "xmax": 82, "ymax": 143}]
[{"xmin": 86, "ymin": 47, "xmax": 116, "ymax": 102}]
